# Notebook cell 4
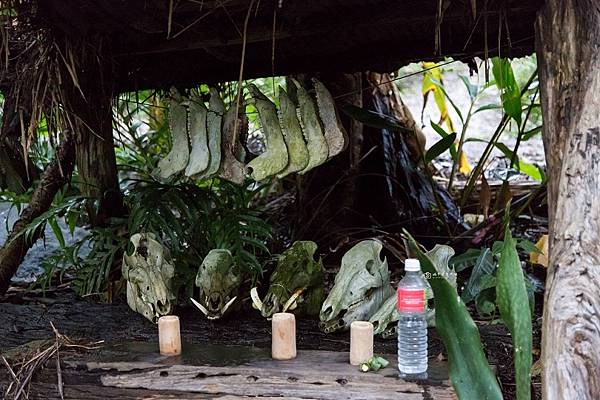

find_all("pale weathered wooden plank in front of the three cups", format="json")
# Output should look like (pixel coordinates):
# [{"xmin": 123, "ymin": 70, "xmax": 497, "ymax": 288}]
[{"xmin": 88, "ymin": 350, "xmax": 455, "ymax": 400}]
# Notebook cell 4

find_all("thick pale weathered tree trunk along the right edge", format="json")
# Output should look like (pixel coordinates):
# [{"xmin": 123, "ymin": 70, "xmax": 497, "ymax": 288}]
[{"xmin": 536, "ymin": 0, "xmax": 600, "ymax": 399}]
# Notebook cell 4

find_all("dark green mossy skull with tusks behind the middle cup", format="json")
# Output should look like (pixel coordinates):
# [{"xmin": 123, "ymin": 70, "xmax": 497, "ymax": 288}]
[{"xmin": 250, "ymin": 241, "xmax": 324, "ymax": 318}]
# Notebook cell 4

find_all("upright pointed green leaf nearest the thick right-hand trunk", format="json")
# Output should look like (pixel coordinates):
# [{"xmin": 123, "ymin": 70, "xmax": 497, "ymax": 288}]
[{"xmin": 496, "ymin": 216, "xmax": 532, "ymax": 400}]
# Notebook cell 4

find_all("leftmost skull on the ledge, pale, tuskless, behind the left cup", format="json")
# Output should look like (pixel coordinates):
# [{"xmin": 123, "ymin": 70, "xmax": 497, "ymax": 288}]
[{"xmin": 123, "ymin": 233, "xmax": 175, "ymax": 323}]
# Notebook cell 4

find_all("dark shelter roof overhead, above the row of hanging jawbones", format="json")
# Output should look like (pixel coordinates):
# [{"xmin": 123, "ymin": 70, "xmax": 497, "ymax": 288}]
[{"xmin": 38, "ymin": 0, "xmax": 542, "ymax": 91}]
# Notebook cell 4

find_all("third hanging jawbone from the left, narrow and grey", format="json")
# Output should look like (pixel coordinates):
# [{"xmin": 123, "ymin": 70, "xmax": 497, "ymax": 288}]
[{"xmin": 198, "ymin": 88, "xmax": 225, "ymax": 179}]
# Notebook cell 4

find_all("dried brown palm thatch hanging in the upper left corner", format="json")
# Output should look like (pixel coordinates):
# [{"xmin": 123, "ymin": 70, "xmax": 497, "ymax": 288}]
[{"xmin": 0, "ymin": 0, "xmax": 95, "ymax": 159}]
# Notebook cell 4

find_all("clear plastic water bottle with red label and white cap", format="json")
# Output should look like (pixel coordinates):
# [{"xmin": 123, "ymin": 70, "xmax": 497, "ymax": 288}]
[{"xmin": 398, "ymin": 258, "xmax": 427, "ymax": 378}]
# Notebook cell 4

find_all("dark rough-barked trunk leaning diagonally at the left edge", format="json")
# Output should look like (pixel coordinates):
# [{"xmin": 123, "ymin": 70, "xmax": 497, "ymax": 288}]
[{"xmin": 0, "ymin": 134, "xmax": 75, "ymax": 295}]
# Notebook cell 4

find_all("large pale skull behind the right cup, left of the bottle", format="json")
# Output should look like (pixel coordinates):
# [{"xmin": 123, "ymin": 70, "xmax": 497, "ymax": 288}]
[{"xmin": 319, "ymin": 240, "xmax": 394, "ymax": 333}]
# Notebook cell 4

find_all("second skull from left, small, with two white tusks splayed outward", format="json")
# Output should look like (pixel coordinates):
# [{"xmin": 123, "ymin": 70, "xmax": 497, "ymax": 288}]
[{"xmin": 190, "ymin": 249, "xmax": 242, "ymax": 320}]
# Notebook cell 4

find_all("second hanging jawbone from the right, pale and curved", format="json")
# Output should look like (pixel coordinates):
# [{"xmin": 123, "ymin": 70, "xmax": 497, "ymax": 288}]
[{"xmin": 292, "ymin": 79, "xmax": 329, "ymax": 174}]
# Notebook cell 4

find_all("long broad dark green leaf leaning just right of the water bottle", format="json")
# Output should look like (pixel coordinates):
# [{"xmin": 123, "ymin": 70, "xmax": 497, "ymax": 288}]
[{"xmin": 405, "ymin": 231, "xmax": 502, "ymax": 400}]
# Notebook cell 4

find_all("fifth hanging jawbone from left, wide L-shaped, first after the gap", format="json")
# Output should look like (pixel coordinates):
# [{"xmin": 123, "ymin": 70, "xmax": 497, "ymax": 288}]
[{"xmin": 248, "ymin": 84, "xmax": 288, "ymax": 181}]
